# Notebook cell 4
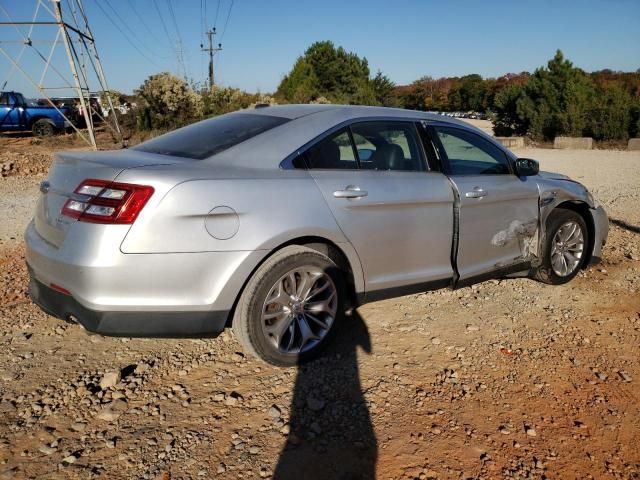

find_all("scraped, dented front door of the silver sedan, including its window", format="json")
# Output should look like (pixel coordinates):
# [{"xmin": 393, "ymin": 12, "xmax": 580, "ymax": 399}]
[{"xmin": 432, "ymin": 125, "xmax": 538, "ymax": 280}]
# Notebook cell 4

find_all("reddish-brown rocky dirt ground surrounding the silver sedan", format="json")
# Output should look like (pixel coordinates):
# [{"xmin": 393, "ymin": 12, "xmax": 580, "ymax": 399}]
[{"xmin": 0, "ymin": 132, "xmax": 640, "ymax": 479}]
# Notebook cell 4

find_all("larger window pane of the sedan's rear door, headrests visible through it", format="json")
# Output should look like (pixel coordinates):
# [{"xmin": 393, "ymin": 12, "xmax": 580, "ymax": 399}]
[{"xmin": 351, "ymin": 121, "xmax": 425, "ymax": 171}]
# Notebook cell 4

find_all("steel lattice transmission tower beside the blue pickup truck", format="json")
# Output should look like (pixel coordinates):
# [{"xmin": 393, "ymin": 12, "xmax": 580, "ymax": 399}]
[{"xmin": 0, "ymin": 0, "xmax": 122, "ymax": 149}]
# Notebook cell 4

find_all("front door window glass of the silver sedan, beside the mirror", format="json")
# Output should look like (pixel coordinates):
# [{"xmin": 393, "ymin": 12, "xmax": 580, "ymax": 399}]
[{"xmin": 434, "ymin": 127, "xmax": 510, "ymax": 175}]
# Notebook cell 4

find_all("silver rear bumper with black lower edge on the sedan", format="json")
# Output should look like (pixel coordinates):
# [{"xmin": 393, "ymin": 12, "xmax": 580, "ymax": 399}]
[{"xmin": 25, "ymin": 222, "xmax": 267, "ymax": 337}]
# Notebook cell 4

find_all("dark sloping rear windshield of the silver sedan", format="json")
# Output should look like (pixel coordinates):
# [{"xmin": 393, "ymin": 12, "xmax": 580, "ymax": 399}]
[{"xmin": 133, "ymin": 113, "xmax": 289, "ymax": 160}]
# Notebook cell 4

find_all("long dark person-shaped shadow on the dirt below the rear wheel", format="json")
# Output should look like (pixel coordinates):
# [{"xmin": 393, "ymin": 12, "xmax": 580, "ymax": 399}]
[{"xmin": 273, "ymin": 311, "xmax": 378, "ymax": 480}]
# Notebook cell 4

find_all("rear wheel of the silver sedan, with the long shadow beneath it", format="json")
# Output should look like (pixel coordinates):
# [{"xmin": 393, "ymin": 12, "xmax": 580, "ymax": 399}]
[{"xmin": 232, "ymin": 245, "xmax": 346, "ymax": 367}]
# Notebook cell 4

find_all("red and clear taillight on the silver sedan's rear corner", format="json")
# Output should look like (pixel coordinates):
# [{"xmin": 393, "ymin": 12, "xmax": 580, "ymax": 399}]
[{"xmin": 62, "ymin": 179, "xmax": 153, "ymax": 224}]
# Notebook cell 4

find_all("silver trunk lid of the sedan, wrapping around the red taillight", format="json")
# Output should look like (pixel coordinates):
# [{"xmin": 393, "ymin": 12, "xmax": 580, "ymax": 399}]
[{"xmin": 34, "ymin": 150, "xmax": 183, "ymax": 248}]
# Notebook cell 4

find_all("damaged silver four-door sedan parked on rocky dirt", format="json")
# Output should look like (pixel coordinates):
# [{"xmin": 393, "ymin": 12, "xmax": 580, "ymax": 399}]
[{"xmin": 26, "ymin": 105, "xmax": 608, "ymax": 365}]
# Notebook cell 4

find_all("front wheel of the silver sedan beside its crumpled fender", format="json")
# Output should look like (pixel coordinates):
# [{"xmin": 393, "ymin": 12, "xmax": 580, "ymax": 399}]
[{"xmin": 534, "ymin": 208, "xmax": 589, "ymax": 285}]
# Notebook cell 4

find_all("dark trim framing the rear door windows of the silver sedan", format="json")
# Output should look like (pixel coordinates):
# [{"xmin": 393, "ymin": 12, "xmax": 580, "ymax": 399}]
[{"xmin": 279, "ymin": 117, "xmax": 434, "ymax": 173}]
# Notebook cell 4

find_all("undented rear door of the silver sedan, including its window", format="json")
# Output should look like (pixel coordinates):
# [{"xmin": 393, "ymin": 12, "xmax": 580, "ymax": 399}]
[{"xmin": 305, "ymin": 121, "xmax": 453, "ymax": 300}]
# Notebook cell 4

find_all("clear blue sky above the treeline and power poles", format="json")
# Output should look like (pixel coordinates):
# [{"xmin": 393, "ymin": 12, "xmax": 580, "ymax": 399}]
[{"xmin": 0, "ymin": 0, "xmax": 640, "ymax": 96}]
